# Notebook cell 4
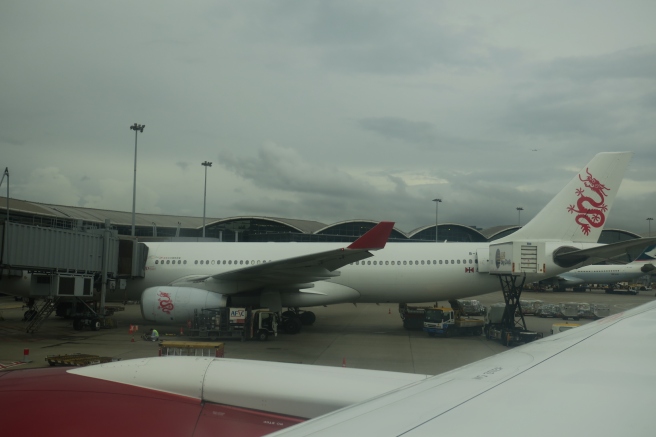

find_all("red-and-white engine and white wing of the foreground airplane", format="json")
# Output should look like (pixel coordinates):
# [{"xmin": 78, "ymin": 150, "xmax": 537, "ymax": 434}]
[{"xmin": 0, "ymin": 294, "xmax": 656, "ymax": 437}]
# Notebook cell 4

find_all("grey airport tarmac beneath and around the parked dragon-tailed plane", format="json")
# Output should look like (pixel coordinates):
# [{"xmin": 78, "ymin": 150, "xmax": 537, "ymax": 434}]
[{"xmin": 0, "ymin": 290, "xmax": 655, "ymax": 375}]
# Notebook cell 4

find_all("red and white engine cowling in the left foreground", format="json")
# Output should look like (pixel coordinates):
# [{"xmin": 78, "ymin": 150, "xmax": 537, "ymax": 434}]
[{"xmin": 0, "ymin": 357, "xmax": 428, "ymax": 437}]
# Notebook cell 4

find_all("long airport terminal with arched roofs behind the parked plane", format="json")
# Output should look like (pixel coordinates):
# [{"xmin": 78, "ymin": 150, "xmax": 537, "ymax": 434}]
[{"xmin": 0, "ymin": 197, "xmax": 640, "ymax": 244}]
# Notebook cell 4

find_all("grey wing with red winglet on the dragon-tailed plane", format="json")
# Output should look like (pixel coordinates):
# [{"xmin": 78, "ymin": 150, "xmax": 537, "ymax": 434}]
[{"xmin": 171, "ymin": 222, "xmax": 394, "ymax": 294}]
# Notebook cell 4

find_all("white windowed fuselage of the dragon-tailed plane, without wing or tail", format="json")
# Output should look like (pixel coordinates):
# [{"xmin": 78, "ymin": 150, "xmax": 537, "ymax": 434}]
[{"xmin": 128, "ymin": 238, "xmax": 597, "ymax": 306}]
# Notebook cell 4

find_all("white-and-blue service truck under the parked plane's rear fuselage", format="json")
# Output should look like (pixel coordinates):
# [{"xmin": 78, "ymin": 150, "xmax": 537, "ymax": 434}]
[{"xmin": 424, "ymin": 300, "xmax": 485, "ymax": 337}]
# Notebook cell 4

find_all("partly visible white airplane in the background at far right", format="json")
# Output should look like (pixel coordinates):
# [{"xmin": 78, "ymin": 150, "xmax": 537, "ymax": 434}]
[{"xmin": 545, "ymin": 246, "xmax": 656, "ymax": 289}]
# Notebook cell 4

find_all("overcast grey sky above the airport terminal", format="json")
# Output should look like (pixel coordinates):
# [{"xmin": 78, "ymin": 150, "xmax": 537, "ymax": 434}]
[{"xmin": 0, "ymin": 0, "xmax": 656, "ymax": 233}]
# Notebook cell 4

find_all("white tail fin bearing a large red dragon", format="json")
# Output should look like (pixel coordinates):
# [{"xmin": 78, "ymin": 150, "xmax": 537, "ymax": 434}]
[{"xmin": 504, "ymin": 152, "xmax": 633, "ymax": 243}]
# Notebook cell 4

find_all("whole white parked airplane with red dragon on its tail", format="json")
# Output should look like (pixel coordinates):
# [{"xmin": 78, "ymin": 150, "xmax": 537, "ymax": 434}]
[{"xmin": 130, "ymin": 152, "xmax": 656, "ymax": 332}]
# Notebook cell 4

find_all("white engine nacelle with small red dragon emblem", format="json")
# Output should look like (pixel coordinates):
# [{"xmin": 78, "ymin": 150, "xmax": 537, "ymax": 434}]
[{"xmin": 141, "ymin": 286, "xmax": 228, "ymax": 323}]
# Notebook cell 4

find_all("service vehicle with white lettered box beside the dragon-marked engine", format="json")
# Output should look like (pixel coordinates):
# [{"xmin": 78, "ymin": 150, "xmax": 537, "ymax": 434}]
[{"xmin": 188, "ymin": 308, "xmax": 278, "ymax": 341}]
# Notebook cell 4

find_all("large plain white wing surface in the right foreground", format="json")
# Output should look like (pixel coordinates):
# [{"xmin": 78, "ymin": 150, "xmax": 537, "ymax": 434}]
[{"xmin": 273, "ymin": 302, "xmax": 656, "ymax": 437}]
